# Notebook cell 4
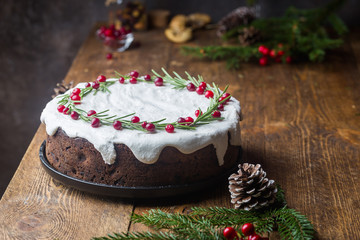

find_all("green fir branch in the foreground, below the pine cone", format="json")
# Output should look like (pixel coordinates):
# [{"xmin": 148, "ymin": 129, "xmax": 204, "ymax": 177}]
[{"xmin": 94, "ymin": 187, "xmax": 314, "ymax": 240}]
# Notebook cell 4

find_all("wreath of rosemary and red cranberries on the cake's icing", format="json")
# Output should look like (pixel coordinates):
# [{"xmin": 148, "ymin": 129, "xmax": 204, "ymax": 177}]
[{"xmin": 57, "ymin": 68, "xmax": 231, "ymax": 133}]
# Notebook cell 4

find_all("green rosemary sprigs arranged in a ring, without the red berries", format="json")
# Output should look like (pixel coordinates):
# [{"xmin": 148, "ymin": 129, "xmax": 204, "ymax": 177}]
[{"xmin": 58, "ymin": 68, "xmax": 230, "ymax": 131}]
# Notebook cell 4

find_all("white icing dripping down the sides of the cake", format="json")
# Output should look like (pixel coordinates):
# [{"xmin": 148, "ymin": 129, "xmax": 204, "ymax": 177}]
[{"xmin": 40, "ymin": 79, "xmax": 241, "ymax": 165}]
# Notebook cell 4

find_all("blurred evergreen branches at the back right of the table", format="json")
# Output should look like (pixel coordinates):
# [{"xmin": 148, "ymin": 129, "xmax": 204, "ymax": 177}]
[{"xmin": 182, "ymin": 0, "xmax": 348, "ymax": 68}]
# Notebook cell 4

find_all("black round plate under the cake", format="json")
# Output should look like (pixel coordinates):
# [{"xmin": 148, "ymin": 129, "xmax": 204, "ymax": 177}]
[{"xmin": 39, "ymin": 141, "xmax": 242, "ymax": 199}]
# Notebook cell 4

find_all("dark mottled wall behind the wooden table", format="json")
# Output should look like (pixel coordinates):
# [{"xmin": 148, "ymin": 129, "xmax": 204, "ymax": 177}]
[{"xmin": 0, "ymin": 0, "xmax": 360, "ymax": 196}]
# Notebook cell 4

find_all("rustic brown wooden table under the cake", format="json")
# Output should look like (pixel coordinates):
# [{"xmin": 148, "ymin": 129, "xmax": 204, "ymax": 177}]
[{"xmin": 0, "ymin": 25, "xmax": 360, "ymax": 239}]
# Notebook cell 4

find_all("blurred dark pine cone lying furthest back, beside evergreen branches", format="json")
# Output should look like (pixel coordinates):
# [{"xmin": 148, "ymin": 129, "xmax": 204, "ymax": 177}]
[{"xmin": 216, "ymin": 7, "xmax": 256, "ymax": 37}]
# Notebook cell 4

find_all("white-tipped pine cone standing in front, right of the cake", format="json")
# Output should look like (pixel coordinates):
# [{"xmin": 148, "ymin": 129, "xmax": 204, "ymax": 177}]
[{"xmin": 229, "ymin": 163, "xmax": 277, "ymax": 211}]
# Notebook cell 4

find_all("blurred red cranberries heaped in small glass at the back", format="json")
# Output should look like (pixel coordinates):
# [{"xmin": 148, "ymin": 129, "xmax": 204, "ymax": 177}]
[{"xmin": 96, "ymin": 24, "xmax": 131, "ymax": 49}]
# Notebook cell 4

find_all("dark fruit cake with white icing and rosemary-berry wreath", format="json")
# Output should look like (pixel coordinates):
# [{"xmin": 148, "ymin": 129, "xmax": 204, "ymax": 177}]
[{"xmin": 41, "ymin": 69, "xmax": 240, "ymax": 187}]
